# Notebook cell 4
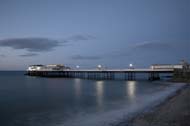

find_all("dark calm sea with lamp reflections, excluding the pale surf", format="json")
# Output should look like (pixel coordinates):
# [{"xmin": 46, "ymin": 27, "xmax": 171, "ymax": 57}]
[{"xmin": 0, "ymin": 73, "xmax": 177, "ymax": 126}]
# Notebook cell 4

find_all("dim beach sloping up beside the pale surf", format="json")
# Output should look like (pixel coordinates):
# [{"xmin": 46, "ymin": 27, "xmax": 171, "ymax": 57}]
[{"xmin": 116, "ymin": 84, "xmax": 190, "ymax": 126}]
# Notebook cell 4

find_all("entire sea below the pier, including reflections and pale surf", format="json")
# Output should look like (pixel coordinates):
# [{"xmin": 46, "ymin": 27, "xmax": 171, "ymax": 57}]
[{"xmin": 0, "ymin": 72, "xmax": 181, "ymax": 126}]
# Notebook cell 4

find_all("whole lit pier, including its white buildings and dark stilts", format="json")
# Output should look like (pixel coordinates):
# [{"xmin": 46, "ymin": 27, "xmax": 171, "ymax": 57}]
[{"xmin": 26, "ymin": 64, "xmax": 186, "ymax": 80}]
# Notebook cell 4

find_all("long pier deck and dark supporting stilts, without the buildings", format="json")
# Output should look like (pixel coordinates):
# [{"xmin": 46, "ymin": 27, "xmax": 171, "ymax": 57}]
[{"xmin": 26, "ymin": 69, "xmax": 174, "ymax": 80}]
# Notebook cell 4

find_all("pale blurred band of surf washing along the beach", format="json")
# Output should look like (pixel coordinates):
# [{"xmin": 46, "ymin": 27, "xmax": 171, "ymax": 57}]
[{"xmin": 57, "ymin": 83, "xmax": 185, "ymax": 126}]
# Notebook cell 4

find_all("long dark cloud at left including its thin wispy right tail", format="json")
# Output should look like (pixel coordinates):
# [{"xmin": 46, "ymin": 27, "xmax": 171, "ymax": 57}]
[{"xmin": 0, "ymin": 35, "xmax": 95, "ymax": 52}]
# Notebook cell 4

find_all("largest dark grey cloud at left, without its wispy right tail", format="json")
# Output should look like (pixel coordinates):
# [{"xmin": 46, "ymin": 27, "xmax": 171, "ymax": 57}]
[{"xmin": 0, "ymin": 38, "xmax": 61, "ymax": 52}]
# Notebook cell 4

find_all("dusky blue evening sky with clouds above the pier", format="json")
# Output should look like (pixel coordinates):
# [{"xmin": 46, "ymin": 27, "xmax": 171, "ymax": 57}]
[{"xmin": 0, "ymin": 0, "xmax": 190, "ymax": 70}]
